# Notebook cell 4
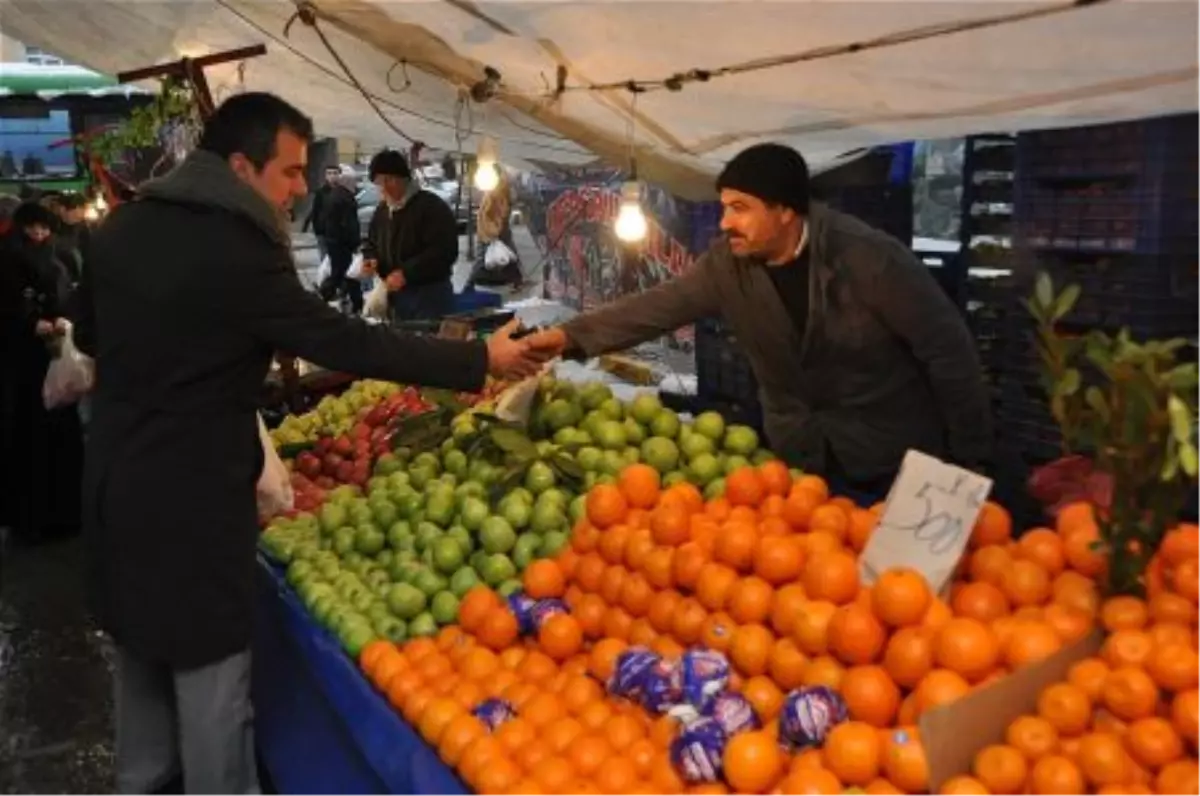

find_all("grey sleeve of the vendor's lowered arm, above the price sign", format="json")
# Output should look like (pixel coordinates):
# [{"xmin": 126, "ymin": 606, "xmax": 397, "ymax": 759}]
[{"xmin": 865, "ymin": 242, "xmax": 992, "ymax": 467}]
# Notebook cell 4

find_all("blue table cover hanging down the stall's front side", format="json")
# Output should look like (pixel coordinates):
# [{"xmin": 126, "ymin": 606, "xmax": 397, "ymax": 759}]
[{"xmin": 253, "ymin": 557, "xmax": 469, "ymax": 796}]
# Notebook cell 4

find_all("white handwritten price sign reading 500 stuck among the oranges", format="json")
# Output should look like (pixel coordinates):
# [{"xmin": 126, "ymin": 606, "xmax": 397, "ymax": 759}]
[{"xmin": 859, "ymin": 450, "xmax": 991, "ymax": 593}]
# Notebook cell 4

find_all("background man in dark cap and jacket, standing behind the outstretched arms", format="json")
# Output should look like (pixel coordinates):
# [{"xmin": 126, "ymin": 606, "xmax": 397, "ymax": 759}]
[{"xmin": 362, "ymin": 150, "xmax": 458, "ymax": 322}]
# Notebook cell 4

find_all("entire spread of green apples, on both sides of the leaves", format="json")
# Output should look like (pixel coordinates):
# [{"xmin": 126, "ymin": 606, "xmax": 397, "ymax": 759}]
[{"xmin": 260, "ymin": 378, "xmax": 772, "ymax": 656}]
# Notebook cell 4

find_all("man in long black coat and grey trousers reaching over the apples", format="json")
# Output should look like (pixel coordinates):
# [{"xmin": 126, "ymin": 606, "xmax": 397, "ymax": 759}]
[{"xmin": 77, "ymin": 94, "xmax": 554, "ymax": 796}]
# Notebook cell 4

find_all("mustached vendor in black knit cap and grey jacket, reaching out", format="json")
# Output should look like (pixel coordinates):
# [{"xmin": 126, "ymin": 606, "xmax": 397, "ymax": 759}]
[{"xmin": 539, "ymin": 144, "xmax": 991, "ymax": 499}]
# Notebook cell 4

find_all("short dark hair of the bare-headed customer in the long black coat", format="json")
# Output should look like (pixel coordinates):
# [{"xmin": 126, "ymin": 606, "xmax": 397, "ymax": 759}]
[{"xmin": 198, "ymin": 91, "xmax": 313, "ymax": 170}]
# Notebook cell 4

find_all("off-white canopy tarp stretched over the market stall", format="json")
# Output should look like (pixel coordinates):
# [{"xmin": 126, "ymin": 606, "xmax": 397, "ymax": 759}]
[{"xmin": 0, "ymin": 0, "xmax": 1200, "ymax": 198}]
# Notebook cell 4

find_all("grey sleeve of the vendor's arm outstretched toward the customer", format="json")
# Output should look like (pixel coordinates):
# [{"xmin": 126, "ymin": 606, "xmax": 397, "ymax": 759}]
[{"xmin": 563, "ymin": 253, "xmax": 720, "ymax": 357}]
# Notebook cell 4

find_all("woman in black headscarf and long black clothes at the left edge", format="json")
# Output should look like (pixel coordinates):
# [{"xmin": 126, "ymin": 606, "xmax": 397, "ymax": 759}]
[{"xmin": 0, "ymin": 203, "xmax": 83, "ymax": 539}]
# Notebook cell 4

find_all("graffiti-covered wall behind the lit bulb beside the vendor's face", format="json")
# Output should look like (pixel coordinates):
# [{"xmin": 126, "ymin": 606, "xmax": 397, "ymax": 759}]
[{"xmin": 529, "ymin": 169, "xmax": 697, "ymax": 346}]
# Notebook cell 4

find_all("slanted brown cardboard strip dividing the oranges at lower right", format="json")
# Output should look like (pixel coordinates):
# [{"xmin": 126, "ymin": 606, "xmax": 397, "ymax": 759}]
[{"xmin": 917, "ymin": 632, "xmax": 1104, "ymax": 794}]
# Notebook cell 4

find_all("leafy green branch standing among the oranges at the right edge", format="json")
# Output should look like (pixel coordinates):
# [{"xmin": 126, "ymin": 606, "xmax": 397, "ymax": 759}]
[{"xmin": 1026, "ymin": 274, "xmax": 1200, "ymax": 593}]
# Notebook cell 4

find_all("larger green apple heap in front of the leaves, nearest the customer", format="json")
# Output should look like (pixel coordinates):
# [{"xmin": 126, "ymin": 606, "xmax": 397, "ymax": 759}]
[{"xmin": 260, "ymin": 448, "xmax": 571, "ymax": 654}]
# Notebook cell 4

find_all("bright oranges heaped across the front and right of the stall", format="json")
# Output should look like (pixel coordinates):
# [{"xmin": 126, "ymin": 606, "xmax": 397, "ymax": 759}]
[{"xmin": 364, "ymin": 453, "xmax": 1200, "ymax": 796}]
